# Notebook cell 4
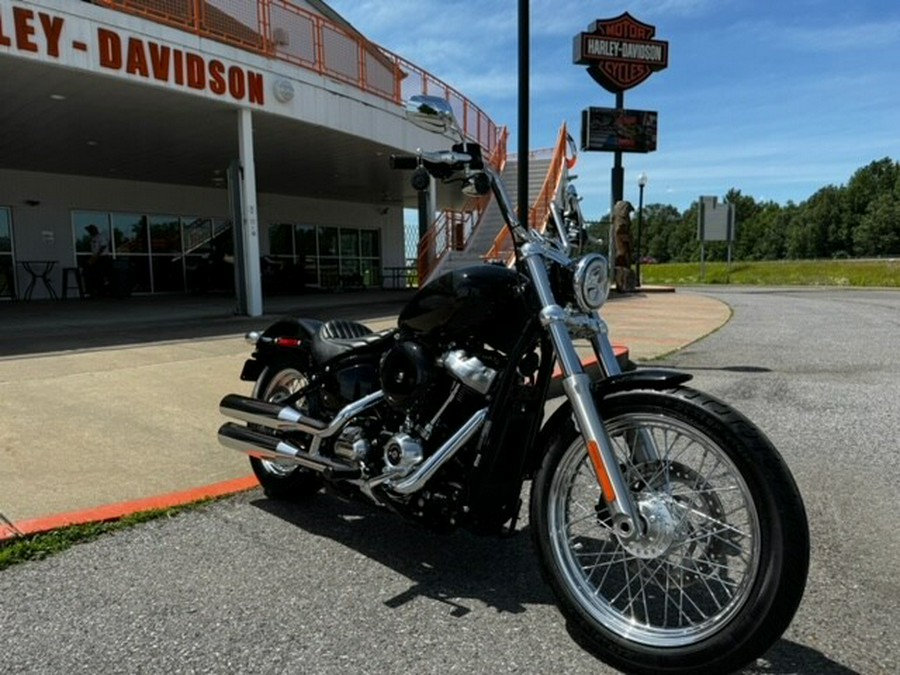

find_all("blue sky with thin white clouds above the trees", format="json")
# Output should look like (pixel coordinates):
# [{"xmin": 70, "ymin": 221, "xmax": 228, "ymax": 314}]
[{"xmin": 329, "ymin": 0, "xmax": 900, "ymax": 219}]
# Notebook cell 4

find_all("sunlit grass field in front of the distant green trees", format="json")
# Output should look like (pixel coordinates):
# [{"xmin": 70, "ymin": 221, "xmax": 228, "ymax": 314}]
[{"xmin": 641, "ymin": 258, "xmax": 900, "ymax": 288}]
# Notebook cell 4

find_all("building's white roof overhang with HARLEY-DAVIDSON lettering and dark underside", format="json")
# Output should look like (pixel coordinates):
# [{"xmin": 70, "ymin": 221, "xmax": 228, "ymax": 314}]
[{"xmin": 0, "ymin": 0, "xmax": 460, "ymax": 206}]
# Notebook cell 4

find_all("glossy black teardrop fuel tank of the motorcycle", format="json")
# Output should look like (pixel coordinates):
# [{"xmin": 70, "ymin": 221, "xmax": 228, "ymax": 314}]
[{"xmin": 398, "ymin": 264, "xmax": 530, "ymax": 352}]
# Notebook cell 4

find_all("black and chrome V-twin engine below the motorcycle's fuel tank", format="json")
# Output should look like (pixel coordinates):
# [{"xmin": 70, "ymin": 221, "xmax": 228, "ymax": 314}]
[{"xmin": 322, "ymin": 338, "xmax": 505, "ymax": 529}]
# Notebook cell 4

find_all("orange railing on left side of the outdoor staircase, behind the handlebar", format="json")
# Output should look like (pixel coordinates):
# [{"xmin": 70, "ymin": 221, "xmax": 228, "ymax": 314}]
[{"xmin": 417, "ymin": 127, "xmax": 509, "ymax": 284}]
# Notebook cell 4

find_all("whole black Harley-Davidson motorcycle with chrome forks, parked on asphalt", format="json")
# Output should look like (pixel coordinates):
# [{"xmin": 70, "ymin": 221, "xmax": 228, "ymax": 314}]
[{"xmin": 219, "ymin": 96, "xmax": 809, "ymax": 674}]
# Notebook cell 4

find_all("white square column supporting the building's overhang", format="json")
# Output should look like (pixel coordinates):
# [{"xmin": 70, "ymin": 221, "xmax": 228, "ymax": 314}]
[{"xmin": 238, "ymin": 108, "xmax": 263, "ymax": 316}]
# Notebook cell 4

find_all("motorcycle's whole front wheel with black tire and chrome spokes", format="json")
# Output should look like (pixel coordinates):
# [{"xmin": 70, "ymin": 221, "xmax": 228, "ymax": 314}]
[{"xmin": 530, "ymin": 388, "xmax": 809, "ymax": 674}]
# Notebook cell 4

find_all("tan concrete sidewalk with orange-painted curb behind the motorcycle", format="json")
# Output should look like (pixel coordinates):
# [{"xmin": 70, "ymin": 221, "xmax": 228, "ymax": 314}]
[{"xmin": 0, "ymin": 291, "xmax": 731, "ymax": 539}]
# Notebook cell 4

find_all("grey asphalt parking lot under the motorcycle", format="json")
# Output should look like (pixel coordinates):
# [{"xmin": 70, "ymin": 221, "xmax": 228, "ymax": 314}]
[{"xmin": 0, "ymin": 288, "xmax": 900, "ymax": 675}]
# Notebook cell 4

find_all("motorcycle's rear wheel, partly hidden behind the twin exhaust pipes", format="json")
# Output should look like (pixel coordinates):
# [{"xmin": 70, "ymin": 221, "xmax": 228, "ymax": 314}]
[{"xmin": 250, "ymin": 366, "xmax": 322, "ymax": 501}]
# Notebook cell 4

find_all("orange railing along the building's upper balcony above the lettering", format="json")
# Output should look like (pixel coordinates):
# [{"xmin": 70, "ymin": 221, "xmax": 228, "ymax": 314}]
[{"xmin": 94, "ymin": 0, "xmax": 500, "ymax": 149}]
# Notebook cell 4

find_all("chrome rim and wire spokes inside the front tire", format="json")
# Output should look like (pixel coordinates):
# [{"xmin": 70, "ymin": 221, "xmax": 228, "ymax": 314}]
[{"xmin": 548, "ymin": 415, "xmax": 760, "ymax": 647}]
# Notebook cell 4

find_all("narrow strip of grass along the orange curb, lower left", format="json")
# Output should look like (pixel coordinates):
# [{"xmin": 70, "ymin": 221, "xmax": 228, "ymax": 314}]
[{"xmin": 0, "ymin": 499, "xmax": 215, "ymax": 571}]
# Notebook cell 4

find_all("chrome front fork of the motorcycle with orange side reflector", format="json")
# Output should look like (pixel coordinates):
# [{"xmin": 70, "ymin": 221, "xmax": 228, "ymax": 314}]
[{"xmin": 522, "ymin": 243, "xmax": 642, "ymax": 540}]
